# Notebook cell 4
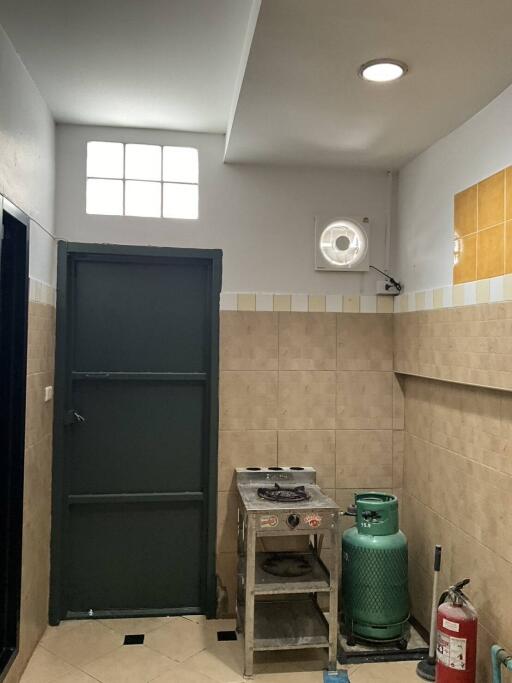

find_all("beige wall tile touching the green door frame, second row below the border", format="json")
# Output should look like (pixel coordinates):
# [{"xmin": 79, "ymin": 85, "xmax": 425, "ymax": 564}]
[{"xmin": 219, "ymin": 370, "xmax": 277, "ymax": 430}]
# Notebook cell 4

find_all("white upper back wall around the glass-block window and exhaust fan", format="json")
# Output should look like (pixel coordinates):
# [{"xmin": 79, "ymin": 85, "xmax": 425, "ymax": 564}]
[{"xmin": 56, "ymin": 125, "xmax": 388, "ymax": 294}]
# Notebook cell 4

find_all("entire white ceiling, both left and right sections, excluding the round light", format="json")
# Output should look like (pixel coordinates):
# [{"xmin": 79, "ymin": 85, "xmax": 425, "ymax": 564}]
[{"xmin": 0, "ymin": 0, "xmax": 512, "ymax": 169}]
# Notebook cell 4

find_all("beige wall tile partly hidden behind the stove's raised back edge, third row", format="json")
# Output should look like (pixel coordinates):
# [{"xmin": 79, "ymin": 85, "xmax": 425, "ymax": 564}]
[{"xmin": 278, "ymin": 429, "xmax": 335, "ymax": 489}]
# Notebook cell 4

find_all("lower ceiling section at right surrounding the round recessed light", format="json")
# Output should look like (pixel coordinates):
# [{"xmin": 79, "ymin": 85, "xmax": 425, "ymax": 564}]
[{"xmin": 226, "ymin": 0, "xmax": 512, "ymax": 169}]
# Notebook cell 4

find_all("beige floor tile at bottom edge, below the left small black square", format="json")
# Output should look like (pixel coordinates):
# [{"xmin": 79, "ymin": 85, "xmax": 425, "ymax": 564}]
[{"xmin": 83, "ymin": 645, "xmax": 173, "ymax": 683}]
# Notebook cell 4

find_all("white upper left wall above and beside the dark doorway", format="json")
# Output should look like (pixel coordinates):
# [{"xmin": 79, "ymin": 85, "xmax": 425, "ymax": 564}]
[{"xmin": 0, "ymin": 27, "xmax": 55, "ymax": 284}]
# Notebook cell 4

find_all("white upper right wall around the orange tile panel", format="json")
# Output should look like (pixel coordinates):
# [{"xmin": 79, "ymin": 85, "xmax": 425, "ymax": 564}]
[{"xmin": 395, "ymin": 86, "xmax": 512, "ymax": 291}]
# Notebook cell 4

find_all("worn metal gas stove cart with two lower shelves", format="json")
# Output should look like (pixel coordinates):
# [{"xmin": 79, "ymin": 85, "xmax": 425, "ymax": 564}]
[{"xmin": 236, "ymin": 467, "xmax": 340, "ymax": 676}]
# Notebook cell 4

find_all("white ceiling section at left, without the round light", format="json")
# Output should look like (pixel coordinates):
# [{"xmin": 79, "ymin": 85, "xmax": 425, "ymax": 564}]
[{"xmin": 0, "ymin": 0, "xmax": 251, "ymax": 133}]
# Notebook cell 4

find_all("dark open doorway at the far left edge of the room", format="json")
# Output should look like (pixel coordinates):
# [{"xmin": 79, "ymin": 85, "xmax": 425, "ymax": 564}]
[{"xmin": 0, "ymin": 197, "xmax": 29, "ymax": 679}]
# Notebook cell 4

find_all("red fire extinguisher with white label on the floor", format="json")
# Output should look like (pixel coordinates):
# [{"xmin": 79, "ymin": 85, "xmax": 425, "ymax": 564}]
[{"xmin": 436, "ymin": 579, "xmax": 478, "ymax": 683}]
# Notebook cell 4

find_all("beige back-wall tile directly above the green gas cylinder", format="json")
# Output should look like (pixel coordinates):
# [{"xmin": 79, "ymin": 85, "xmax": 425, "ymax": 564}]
[{"xmin": 336, "ymin": 429, "xmax": 393, "ymax": 489}]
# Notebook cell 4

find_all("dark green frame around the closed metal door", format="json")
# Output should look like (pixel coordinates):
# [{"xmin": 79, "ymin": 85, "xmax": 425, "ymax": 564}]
[{"xmin": 49, "ymin": 240, "xmax": 222, "ymax": 625}]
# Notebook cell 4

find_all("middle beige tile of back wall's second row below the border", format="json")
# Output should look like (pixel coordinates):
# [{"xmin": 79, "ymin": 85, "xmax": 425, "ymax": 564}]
[{"xmin": 278, "ymin": 371, "xmax": 336, "ymax": 429}]
